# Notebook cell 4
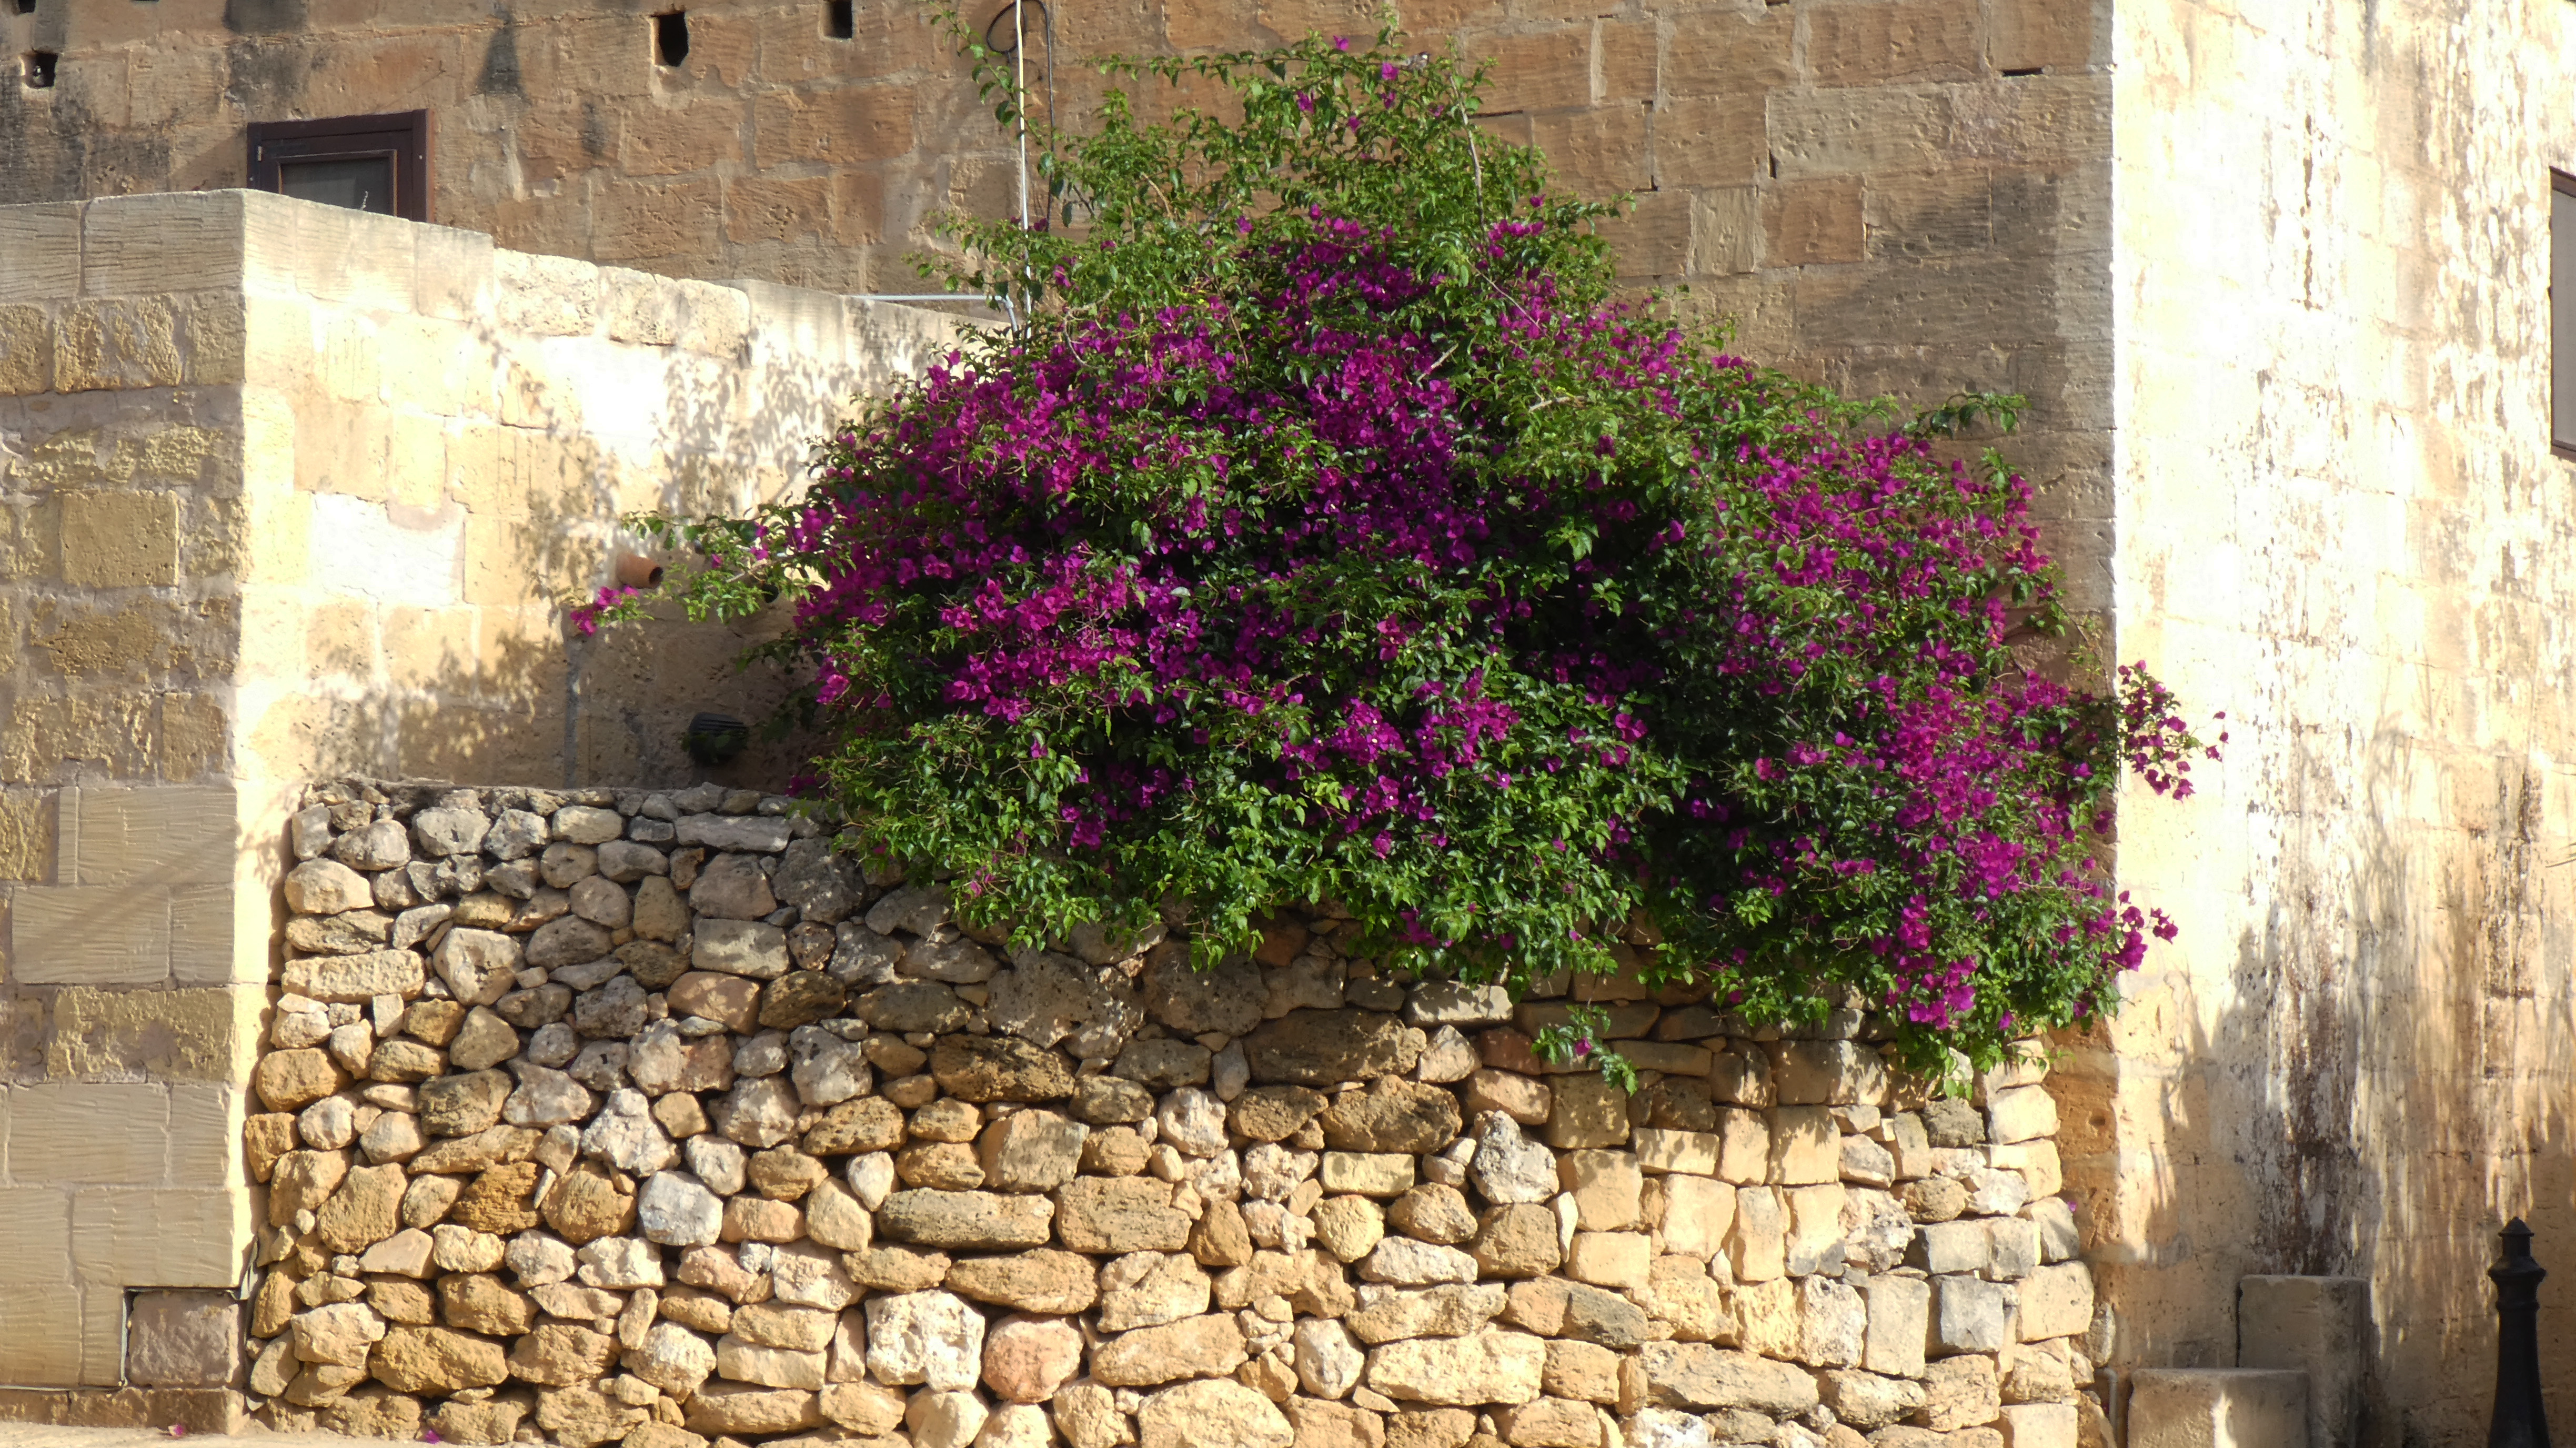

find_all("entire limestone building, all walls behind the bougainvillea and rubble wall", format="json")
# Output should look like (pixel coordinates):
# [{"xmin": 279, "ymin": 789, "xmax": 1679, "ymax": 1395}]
[{"xmin": 0, "ymin": 0, "xmax": 2576, "ymax": 1443}]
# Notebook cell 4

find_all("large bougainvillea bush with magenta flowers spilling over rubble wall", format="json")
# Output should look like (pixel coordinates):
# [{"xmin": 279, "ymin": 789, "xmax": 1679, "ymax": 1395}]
[{"xmin": 603, "ymin": 25, "xmax": 2197, "ymax": 1064}]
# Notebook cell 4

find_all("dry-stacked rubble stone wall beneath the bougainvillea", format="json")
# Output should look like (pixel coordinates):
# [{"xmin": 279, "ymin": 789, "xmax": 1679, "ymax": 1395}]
[{"xmin": 250, "ymin": 783, "xmax": 2092, "ymax": 1448}]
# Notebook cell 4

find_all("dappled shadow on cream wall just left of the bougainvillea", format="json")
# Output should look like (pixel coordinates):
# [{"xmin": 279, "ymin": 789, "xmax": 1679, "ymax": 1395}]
[{"xmin": 304, "ymin": 278, "xmax": 973, "ymax": 791}]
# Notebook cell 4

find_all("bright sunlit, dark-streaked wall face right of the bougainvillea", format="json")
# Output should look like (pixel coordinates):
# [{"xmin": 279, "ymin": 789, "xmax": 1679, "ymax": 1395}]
[{"xmin": 2053, "ymin": 0, "xmax": 2576, "ymax": 1443}]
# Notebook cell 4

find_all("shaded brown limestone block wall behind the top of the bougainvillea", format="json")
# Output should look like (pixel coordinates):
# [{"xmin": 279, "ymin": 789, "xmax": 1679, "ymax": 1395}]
[{"xmin": 0, "ymin": 0, "xmax": 2112, "ymax": 618}]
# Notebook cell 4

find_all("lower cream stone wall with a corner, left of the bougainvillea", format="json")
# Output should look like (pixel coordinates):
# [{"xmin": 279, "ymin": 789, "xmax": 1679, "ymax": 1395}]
[{"xmin": 0, "ymin": 190, "xmax": 953, "ymax": 1391}]
